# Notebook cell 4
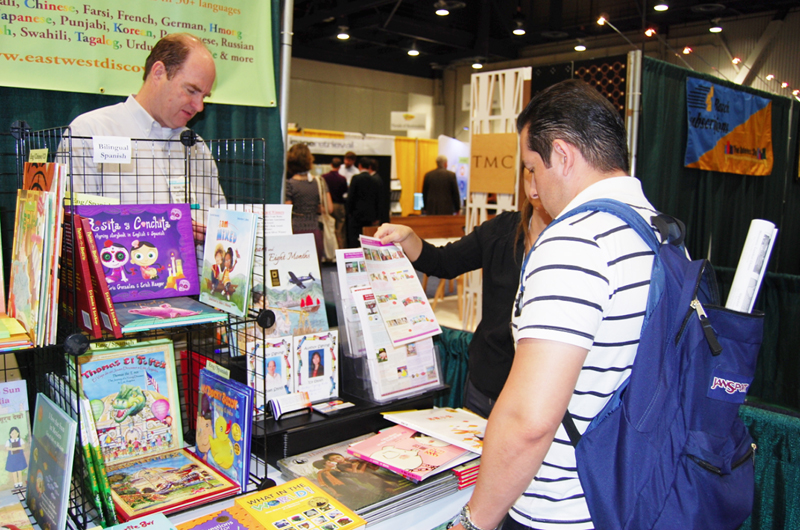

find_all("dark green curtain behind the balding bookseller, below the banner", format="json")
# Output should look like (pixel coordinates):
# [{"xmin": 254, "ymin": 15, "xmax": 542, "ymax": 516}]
[{"xmin": 0, "ymin": 2, "xmax": 283, "ymax": 204}]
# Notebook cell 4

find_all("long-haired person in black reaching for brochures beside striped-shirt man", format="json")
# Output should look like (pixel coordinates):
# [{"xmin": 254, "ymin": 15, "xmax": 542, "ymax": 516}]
[{"xmin": 375, "ymin": 165, "xmax": 550, "ymax": 418}]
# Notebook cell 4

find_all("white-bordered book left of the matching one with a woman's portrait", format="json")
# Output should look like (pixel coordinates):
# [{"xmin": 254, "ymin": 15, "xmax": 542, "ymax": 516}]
[{"xmin": 247, "ymin": 337, "xmax": 295, "ymax": 413}]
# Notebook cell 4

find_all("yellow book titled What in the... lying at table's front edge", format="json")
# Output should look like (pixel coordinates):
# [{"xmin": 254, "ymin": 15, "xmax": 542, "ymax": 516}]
[{"xmin": 235, "ymin": 478, "xmax": 367, "ymax": 530}]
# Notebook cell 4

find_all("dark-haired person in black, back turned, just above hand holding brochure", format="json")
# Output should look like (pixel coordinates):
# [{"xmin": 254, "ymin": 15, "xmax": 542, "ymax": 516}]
[{"xmin": 340, "ymin": 157, "xmax": 389, "ymax": 248}]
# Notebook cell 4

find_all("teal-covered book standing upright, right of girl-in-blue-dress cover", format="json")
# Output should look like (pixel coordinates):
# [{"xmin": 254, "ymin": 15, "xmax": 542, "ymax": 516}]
[{"xmin": 25, "ymin": 393, "xmax": 78, "ymax": 529}]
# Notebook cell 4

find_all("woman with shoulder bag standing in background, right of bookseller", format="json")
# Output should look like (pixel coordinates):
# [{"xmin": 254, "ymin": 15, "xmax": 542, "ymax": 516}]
[{"xmin": 285, "ymin": 144, "xmax": 333, "ymax": 259}]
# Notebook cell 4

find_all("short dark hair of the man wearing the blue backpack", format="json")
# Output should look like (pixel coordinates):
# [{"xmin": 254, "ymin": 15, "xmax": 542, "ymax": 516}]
[{"xmin": 517, "ymin": 79, "xmax": 630, "ymax": 173}]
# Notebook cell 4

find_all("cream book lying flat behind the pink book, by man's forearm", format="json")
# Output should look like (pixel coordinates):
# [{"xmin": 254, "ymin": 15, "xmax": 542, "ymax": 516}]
[{"xmin": 383, "ymin": 408, "xmax": 487, "ymax": 454}]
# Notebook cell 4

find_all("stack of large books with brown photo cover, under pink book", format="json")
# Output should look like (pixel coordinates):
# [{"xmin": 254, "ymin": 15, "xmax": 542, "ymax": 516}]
[{"xmin": 278, "ymin": 434, "xmax": 458, "ymax": 524}]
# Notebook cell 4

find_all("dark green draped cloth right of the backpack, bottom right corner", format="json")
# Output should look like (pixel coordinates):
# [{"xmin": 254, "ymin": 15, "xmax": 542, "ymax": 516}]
[{"xmin": 739, "ymin": 405, "xmax": 800, "ymax": 530}]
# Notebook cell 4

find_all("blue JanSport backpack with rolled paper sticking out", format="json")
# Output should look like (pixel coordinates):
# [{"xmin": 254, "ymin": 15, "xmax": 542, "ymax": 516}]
[{"xmin": 558, "ymin": 199, "xmax": 764, "ymax": 530}]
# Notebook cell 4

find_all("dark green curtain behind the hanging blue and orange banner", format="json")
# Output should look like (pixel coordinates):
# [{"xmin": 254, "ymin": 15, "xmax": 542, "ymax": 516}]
[{"xmin": 636, "ymin": 58, "xmax": 800, "ymax": 274}]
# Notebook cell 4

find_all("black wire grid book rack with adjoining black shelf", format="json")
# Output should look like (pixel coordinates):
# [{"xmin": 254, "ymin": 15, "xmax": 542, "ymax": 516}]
[{"xmin": 0, "ymin": 123, "xmax": 447, "ymax": 530}]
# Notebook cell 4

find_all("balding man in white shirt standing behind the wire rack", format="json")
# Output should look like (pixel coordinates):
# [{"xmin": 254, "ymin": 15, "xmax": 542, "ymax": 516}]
[{"xmin": 59, "ymin": 33, "xmax": 225, "ymax": 212}]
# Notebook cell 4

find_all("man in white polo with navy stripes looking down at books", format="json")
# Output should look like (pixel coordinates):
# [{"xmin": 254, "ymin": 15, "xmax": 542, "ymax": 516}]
[{"xmin": 456, "ymin": 80, "xmax": 655, "ymax": 530}]
